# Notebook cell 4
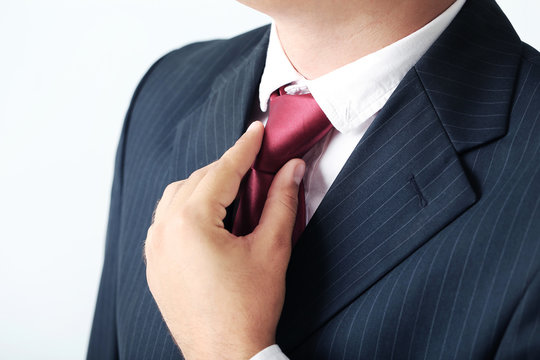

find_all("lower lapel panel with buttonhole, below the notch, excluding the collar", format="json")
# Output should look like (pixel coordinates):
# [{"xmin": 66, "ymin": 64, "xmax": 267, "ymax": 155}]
[{"xmin": 278, "ymin": 71, "xmax": 476, "ymax": 349}]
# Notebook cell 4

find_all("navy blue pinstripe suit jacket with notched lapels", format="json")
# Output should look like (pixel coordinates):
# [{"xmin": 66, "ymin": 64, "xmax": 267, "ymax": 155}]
[{"xmin": 88, "ymin": 0, "xmax": 540, "ymax": 359}]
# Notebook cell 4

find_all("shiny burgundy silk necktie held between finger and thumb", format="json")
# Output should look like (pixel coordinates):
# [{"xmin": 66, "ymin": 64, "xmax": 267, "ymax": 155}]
[{"xmin": 233, "ymin": 87, "xmax": 332, "ymax": 245}]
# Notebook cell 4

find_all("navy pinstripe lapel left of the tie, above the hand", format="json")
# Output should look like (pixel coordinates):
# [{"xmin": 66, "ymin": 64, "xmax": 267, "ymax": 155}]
[{"xmin": 171, "ymin": 27, "xmax": 269, "ymax": 180}]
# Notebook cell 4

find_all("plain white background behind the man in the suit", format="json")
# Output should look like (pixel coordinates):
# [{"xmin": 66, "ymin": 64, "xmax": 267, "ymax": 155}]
[{"xmin": 0, "ymin": 0, "xmax": 540, "ymax": 360}]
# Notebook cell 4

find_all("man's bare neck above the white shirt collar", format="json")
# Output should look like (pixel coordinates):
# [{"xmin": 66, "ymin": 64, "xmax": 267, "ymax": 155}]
[{"xmin": 274, "ymin": 0, "xmax": 455, "ymax": 79}]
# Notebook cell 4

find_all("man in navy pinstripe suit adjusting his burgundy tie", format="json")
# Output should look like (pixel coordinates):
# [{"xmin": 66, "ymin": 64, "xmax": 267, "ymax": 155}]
[{"xmin": 88, "ymin": 0, "xmax": 540, "ymax": 359}]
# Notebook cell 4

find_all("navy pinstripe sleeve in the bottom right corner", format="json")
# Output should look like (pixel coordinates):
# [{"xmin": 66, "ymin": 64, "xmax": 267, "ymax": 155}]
[{"xmin": 495, "ymin": 272, "xmax": 540, "ymax": 360}]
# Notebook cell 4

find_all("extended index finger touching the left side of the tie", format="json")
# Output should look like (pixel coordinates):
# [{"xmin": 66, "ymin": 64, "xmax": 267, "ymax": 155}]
[{"xmin": 193, "ymin": 121, "xmax": 264, "ymax": 213}]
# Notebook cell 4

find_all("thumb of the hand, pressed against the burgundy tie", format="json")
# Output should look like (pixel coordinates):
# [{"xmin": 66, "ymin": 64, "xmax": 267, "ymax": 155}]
[{"xmin": 253, "ymin": 159, "xmax": 306, "ymax": 252}]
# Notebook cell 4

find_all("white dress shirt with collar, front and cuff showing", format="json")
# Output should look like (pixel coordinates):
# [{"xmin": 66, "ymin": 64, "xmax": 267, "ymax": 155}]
[{"xmin": 251, "ymin": 0, "xmax": 465, "ymax": 360}]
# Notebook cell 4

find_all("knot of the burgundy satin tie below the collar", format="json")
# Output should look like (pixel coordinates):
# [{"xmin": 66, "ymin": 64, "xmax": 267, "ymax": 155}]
[{"xmin": 254, "ymin": 92, "xmax": 332, "ymax": 173}]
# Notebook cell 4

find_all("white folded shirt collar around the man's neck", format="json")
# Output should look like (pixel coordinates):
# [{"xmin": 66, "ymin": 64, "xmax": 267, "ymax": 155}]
[{"xmin": 259, "ymin": 0, "xmax": 465, "ymax": 133}]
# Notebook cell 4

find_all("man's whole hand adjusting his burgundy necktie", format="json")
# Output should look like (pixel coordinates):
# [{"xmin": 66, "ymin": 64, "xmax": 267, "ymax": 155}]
[{"xmin": 145, "ymin": 122, "xmax": 305, "ymax": 360}]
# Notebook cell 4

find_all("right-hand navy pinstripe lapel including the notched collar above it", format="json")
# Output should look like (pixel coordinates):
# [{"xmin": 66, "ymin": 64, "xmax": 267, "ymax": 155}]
[{"xmin": 278, "ymin": 0, "xmax": 520, "ymax": 351}]
